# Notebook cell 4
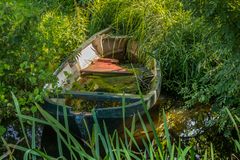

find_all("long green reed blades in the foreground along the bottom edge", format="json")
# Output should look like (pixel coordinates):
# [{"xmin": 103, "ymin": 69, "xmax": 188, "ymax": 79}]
[{"xmin": 2, "ymin": 95, "xmax": 240, "ymax": 160}]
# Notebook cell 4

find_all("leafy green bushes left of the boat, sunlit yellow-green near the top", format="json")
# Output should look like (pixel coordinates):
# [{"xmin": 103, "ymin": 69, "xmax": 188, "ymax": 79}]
[{"xmin": 0, "ymin": 0, "xmax": 88, "ymax": 119}]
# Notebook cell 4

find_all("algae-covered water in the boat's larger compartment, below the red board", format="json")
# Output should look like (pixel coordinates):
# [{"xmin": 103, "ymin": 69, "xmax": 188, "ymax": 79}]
[{"xmin": 71, "ymin": 64, "xmax": 153, "ymax": 94}]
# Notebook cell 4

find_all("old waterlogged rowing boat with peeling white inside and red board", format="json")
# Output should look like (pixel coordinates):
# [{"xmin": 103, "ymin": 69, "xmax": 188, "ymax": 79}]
[{"xmin": 43, "ymin": 28, "xmax": 161, "ymax": 138}]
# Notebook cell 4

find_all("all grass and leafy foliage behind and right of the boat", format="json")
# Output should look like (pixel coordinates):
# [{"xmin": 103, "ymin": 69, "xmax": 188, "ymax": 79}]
[{"xmin": 90, "ymin": 0, "xmax": 240, "ymax": 134}]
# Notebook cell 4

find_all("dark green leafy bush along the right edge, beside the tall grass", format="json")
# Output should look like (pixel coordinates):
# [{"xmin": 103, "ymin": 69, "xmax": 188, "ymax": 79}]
[{"xmin": 182, "ymin": 0, "xmax": 240, "ymax": 136}]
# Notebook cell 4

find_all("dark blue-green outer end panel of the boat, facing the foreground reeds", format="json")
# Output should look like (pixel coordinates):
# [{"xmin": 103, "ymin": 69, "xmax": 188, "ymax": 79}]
[{"xmin": 43, "ymin": 91, "xmax": 159, "ymax": 139}]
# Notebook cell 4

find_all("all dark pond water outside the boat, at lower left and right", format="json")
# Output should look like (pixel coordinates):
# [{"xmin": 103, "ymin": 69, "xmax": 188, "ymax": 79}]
[{"xmin": 0, "ymin": 96, "xmax": 231, "ymax": 156}]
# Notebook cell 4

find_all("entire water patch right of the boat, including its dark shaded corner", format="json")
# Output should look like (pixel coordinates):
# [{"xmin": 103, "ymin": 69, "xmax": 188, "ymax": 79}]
[{"xmin": 135, "ymin": 97, "xmax": 233, "ymax": 158}]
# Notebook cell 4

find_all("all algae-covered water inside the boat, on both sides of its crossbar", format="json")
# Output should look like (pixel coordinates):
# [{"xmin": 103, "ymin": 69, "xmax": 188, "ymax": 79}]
[{"xmin": 65, "ymin": 64, "xmax": 153, "ymax": 112}]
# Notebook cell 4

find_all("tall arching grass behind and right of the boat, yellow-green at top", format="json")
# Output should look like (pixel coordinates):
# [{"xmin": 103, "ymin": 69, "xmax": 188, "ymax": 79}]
[{"xmin": 90, "ymin": 0, "xmax": 229, "ymax": 94}]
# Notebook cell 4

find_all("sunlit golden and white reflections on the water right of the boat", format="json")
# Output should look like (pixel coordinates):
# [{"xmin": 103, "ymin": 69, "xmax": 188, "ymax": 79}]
[{"xmin": 135, "ymin": 97, "xmax": 212, "ymax": 145}]
